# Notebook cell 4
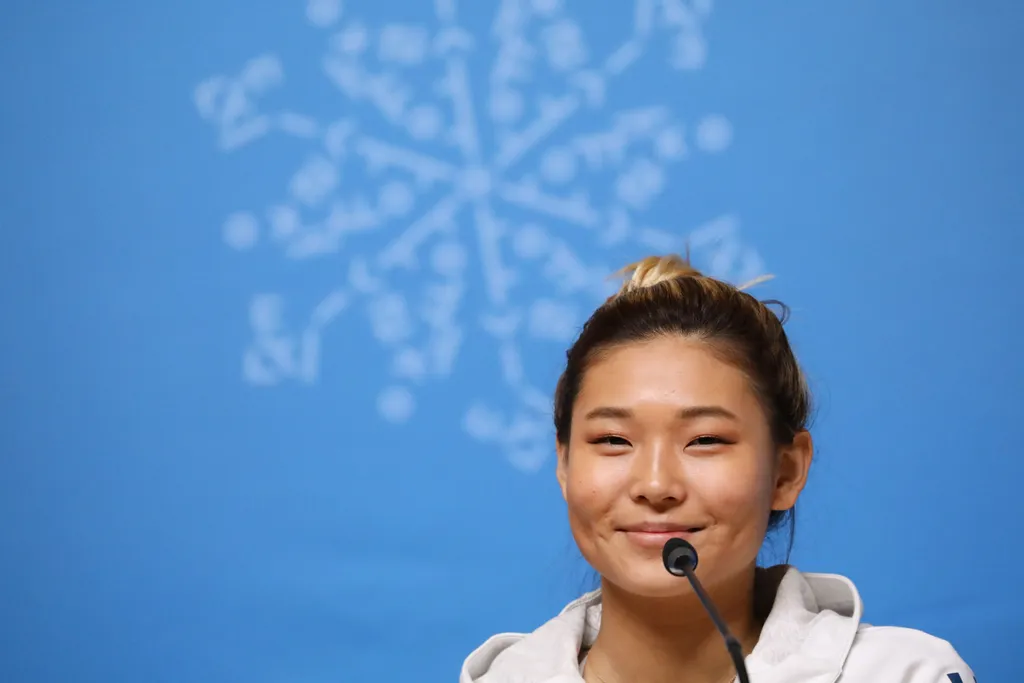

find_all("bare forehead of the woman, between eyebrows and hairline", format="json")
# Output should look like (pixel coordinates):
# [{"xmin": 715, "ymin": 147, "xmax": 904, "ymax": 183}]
[{"xmin": 577, "ymin": 336, "xmax": 760, "ymax": 414}]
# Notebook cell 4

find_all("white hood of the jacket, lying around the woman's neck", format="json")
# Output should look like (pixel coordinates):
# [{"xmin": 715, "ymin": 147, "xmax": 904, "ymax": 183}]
[{"xmin": 459, "ymin": 566, "xmax": 862, "ymax": 683}]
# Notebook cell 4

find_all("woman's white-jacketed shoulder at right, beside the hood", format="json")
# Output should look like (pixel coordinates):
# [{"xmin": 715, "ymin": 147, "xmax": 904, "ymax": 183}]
[{"xmin": 840, "ymin": 625, "xmax": 975, "ymax": 683}]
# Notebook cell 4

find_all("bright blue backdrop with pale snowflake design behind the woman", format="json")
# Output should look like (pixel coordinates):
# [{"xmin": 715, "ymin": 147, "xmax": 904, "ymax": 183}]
[{"xmin": 0, "ymin": 0, "xmax": 1024, "ymax": 683}]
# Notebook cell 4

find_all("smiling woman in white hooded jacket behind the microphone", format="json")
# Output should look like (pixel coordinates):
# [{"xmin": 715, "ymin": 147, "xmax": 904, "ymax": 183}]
[{"xmin": 459, "ymin": 256, "xmax": 974, "ymax": 683}]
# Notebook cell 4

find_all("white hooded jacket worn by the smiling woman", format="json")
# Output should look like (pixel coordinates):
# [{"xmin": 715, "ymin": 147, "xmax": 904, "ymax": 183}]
[{"xmin": 459, "ymin": 567, "xmax": 975, "ymax": 683}]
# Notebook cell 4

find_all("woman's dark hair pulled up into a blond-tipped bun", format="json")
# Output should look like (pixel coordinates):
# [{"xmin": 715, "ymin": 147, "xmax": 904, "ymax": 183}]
[{"xmin": 554, "ymin": 255, "xmax": 811, "ymax": 561}]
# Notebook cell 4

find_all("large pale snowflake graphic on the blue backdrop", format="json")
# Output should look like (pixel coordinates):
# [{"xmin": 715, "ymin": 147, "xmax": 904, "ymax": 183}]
[{"xmin": 194, "ymin": 0, "xmax": 763, "ymax": 472}]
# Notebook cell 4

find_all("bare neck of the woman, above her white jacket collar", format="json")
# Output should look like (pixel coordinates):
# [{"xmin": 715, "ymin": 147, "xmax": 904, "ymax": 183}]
[{"xmin": 585, "ymin": 566, "xmax": 761, "ymax": 683}]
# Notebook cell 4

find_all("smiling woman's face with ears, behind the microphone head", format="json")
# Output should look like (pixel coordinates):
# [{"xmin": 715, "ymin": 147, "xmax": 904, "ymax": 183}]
[{"xmin": 558, "ymin": 336, "xmax": 811, "ymax": 597}]
